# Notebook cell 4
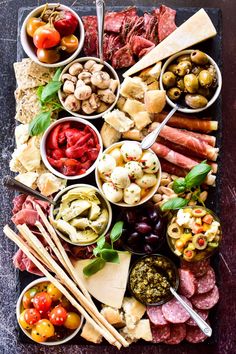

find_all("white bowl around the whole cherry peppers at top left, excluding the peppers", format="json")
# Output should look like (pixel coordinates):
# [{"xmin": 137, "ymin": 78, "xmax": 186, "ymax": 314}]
[{"xmin": 20, "ymin": 3, "xmax": 85, "ymax": 68}]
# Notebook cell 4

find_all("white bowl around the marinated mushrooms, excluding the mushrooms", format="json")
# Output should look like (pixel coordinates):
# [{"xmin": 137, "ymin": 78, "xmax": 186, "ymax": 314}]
[{"xmin": 58, "ymin": 57, "xmax": 120, "ymax": 119}]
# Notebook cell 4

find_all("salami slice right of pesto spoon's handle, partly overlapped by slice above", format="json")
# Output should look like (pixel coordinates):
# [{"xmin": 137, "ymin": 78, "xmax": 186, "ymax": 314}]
[{"xmin": 191, "ymin": 285, "xmax": 219, "ymax": 310}]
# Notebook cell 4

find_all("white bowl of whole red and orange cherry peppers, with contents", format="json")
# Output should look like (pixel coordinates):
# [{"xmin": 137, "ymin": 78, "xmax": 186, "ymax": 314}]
[{"xmin": 20, "ymin": 3, "xmax": 84, "ymax": 67}]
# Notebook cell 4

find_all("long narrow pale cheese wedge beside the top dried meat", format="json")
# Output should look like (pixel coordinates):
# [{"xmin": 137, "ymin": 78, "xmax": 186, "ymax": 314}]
[{"xmin": 123, "ymin": 9, "xmax": 217, "ymax": 77}]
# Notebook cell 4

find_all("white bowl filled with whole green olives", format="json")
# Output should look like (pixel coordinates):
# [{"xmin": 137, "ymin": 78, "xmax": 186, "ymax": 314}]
[{"xmin": 160, "ymin": 49, "xmax": 222, "ymax": 113}]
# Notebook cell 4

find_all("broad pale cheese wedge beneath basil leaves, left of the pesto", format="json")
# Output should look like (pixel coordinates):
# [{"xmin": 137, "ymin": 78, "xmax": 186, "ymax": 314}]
[{"xmin": 73, "ymin": 252, "xmax": 131, "ymax": 309}]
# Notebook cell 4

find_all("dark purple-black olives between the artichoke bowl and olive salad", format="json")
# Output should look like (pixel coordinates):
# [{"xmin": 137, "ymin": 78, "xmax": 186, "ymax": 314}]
[{"xmin": 121, "ymin": 203, "xmax": 166, "ymax": 255}]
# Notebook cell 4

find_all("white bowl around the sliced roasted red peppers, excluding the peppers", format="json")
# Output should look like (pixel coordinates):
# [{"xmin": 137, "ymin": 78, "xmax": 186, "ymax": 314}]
[{"xmin": 40, "ymin": 117, "xmax": 103, "ymax": 180}]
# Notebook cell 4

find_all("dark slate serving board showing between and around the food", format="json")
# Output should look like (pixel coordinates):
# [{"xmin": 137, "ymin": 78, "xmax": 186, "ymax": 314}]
[{"xmin": 17, "ymin": 3, "xmax": 222, "ymax": 348}]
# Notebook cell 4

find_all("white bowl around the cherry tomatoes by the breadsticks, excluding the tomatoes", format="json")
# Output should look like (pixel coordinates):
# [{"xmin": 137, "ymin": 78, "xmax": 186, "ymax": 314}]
[{"xmin": 16, "ymin": 277, "xmax": 84, "ymax": 346}]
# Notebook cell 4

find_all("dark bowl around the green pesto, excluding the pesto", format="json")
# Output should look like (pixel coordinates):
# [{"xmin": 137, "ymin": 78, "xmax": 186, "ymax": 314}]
[{"xmin": 127, "ymin": 253, "xmax": 179, "ymax": 306}]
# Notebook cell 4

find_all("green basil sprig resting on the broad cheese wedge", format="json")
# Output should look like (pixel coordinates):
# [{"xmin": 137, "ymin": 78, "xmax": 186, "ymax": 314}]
[{"xmin": 83, "ymin": 221, "xmax": 124, "ymax": 277}]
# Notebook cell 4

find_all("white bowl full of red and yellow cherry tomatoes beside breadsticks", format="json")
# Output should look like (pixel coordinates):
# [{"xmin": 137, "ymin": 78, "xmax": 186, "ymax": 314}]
[{"xmin": 16, "ymin": 277, "xmax": 84, "ymax": 345}]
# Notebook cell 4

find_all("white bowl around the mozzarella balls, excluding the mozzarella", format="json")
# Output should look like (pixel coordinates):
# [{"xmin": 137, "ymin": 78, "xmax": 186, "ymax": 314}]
[{"xmin": 95, "ymin": 140, "xmax": 161, "ymax": 208}]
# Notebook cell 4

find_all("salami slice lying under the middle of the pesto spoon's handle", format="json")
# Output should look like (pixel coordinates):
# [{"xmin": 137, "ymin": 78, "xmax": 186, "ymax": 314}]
[{"xmin": 162, "ymin": 295, "xmax": 192, "ymax": 323}]
